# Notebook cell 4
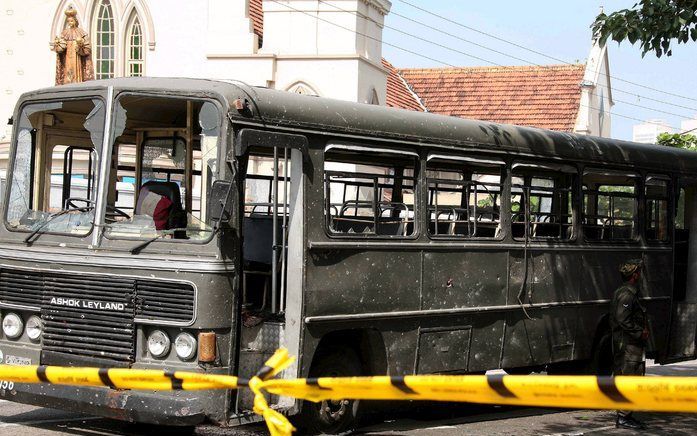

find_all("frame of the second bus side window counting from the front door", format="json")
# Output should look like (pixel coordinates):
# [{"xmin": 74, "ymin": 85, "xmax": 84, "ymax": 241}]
[{"xmin": 423, "ymin": 153, "xmax": 510, "ymax": 243}]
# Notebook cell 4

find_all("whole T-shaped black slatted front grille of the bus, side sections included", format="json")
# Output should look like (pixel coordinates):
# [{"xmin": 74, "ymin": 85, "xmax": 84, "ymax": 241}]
[{"xmin": 0, "ymin": 268, "xmax": 196, "ymax": 366}]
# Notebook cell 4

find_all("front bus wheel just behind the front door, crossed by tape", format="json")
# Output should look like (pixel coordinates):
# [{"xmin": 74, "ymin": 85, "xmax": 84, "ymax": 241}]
[{"xmin": 298, "ymin": 349, "xmax": 363, "ymax": 434}]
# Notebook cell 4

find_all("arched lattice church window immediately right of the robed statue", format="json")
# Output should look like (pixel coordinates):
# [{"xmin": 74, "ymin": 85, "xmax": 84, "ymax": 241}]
[{"xmin": 92, "ymin": 0, "xmax": 116, "ymax": 79}]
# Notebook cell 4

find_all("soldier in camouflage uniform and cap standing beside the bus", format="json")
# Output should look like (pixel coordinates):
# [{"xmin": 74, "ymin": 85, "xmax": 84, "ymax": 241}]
[{"xmin": 610, "ymin": 259, "xmax": 649, "ymax": 429}]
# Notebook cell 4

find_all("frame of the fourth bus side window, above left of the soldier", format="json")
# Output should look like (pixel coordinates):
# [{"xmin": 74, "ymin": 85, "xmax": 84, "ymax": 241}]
[{"xmin": 579, "ymin": 166, "xmax": 645, "ymax": 245}]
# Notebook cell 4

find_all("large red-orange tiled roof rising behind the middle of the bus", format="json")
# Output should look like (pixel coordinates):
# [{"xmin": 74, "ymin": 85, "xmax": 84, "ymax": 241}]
[{"xmin": 394, "ymin": 65, "xmax": 585, "ymax": 131}]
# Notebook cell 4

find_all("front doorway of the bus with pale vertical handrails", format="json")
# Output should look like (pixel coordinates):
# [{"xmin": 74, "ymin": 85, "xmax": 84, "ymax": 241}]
[{"xmin": 233, "ymin": 130, "xmax": 306, "ymax": 413}]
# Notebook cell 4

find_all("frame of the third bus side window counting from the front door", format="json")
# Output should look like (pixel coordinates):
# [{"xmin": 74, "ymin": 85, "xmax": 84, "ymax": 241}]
[{"xmin": 506, "ymin": 160, "xmax": 582, "ymax": 244}]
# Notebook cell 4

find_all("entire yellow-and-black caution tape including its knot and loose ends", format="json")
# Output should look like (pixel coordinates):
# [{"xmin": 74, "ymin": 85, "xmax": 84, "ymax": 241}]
[{"xmin": 0, "ymin": 349, "xmax": 697, "ymax": 436}]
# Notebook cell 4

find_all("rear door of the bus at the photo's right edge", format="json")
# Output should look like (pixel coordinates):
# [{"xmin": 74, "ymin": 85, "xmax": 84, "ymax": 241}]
[{"xmin": 661, "ymin": 178, "xmax": 697, "ymax": 363}]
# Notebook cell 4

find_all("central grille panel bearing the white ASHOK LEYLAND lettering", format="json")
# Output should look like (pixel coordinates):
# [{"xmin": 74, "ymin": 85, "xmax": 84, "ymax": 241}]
[{"xmin": 41, "ymin": 274, "xmax": 135, "ymax": 365}]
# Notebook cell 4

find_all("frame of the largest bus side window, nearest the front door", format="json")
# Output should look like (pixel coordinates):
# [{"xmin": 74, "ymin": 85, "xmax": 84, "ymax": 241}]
[{"xmin": 321, "ymin": 141, "xmax": 423, "ymax": 241}]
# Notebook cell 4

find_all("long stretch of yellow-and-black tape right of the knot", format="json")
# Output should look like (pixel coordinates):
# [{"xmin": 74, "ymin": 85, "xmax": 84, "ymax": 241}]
[{"xmin": 264, "ymin": 375, "xmax": 697, "ymax": 413}]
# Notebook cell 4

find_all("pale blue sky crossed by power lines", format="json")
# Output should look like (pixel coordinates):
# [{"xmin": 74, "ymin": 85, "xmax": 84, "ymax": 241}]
[{"xmin": 383, "ymin": 0, "xmax": 697, "ymax": 139}]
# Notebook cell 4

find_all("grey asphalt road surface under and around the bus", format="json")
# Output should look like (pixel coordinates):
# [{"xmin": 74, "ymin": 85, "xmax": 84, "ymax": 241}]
[{"xmin": 0, "ymin": 361, "xmax": 697, "ymax": 436}]
